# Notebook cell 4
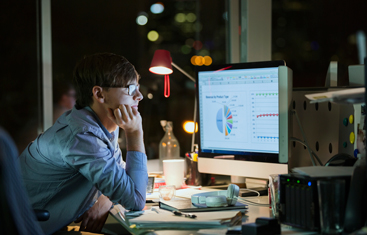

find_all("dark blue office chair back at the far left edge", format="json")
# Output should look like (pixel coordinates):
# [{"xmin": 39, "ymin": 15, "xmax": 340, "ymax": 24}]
[{"xmin": 0, "ymin": 127, "xmax": 45, "ymax": 235}]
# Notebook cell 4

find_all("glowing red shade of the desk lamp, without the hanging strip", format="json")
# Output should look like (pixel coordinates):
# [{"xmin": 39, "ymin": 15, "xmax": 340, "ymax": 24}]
[{"xmin": 149, "ymin": 50, "xmax": 173, "ymax": 75}]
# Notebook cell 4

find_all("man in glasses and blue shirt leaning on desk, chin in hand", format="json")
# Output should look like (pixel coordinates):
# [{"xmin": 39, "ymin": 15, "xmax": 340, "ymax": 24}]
[{"xmin": 20, "ymin": 53, "xmax": 148, "ymax": 234}]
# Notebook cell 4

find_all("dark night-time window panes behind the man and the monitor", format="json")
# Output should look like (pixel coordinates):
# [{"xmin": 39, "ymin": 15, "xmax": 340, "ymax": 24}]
[{"xmin": 0, "ymin": 0, "xmax": 367, "ymax": 158}]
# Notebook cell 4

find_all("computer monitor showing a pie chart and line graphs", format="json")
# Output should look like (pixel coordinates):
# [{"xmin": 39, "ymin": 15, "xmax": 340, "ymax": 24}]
[{"xmin": 196, "ymin": 61, "xmax": 292, "ymax": 179}]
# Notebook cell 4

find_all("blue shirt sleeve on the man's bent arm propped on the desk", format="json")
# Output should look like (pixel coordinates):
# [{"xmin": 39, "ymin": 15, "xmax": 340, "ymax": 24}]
[{"xmin": 64, "ymin": 133, "xmax": 148, "ymax": 210}]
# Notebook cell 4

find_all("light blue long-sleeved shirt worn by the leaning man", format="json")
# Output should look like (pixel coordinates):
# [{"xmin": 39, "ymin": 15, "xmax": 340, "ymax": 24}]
[{"xmin": 19, "ymin": 107, "xmax": 148, "ymax": 234}]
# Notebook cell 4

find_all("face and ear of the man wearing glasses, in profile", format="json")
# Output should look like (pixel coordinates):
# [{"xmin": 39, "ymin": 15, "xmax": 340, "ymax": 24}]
[{"xmin": 103, "ymin": 80, "xmax": 143, "ymax": 110}]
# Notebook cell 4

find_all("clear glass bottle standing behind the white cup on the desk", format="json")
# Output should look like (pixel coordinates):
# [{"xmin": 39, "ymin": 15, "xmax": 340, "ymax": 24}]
[{"xmin": 159, "ymin": 120, "xmax": 180, "ymax": 171}]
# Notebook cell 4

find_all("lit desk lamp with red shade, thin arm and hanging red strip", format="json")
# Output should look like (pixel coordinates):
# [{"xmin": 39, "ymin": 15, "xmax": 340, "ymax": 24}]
[{"xmin": 149, "ymin": 50, "xmax": 196, "ymax": 152}]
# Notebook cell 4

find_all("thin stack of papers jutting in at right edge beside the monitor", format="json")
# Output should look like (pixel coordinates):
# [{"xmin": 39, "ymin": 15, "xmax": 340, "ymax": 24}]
[{"xmin": 305, "ymin": 87, "xmax": 365, "ymax": 104}]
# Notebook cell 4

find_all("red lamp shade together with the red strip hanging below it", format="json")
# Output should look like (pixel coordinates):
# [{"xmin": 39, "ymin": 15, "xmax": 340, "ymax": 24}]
[{"xmin": 149, "ymin": 50, "xmax": 173, "ymax": 98}]
